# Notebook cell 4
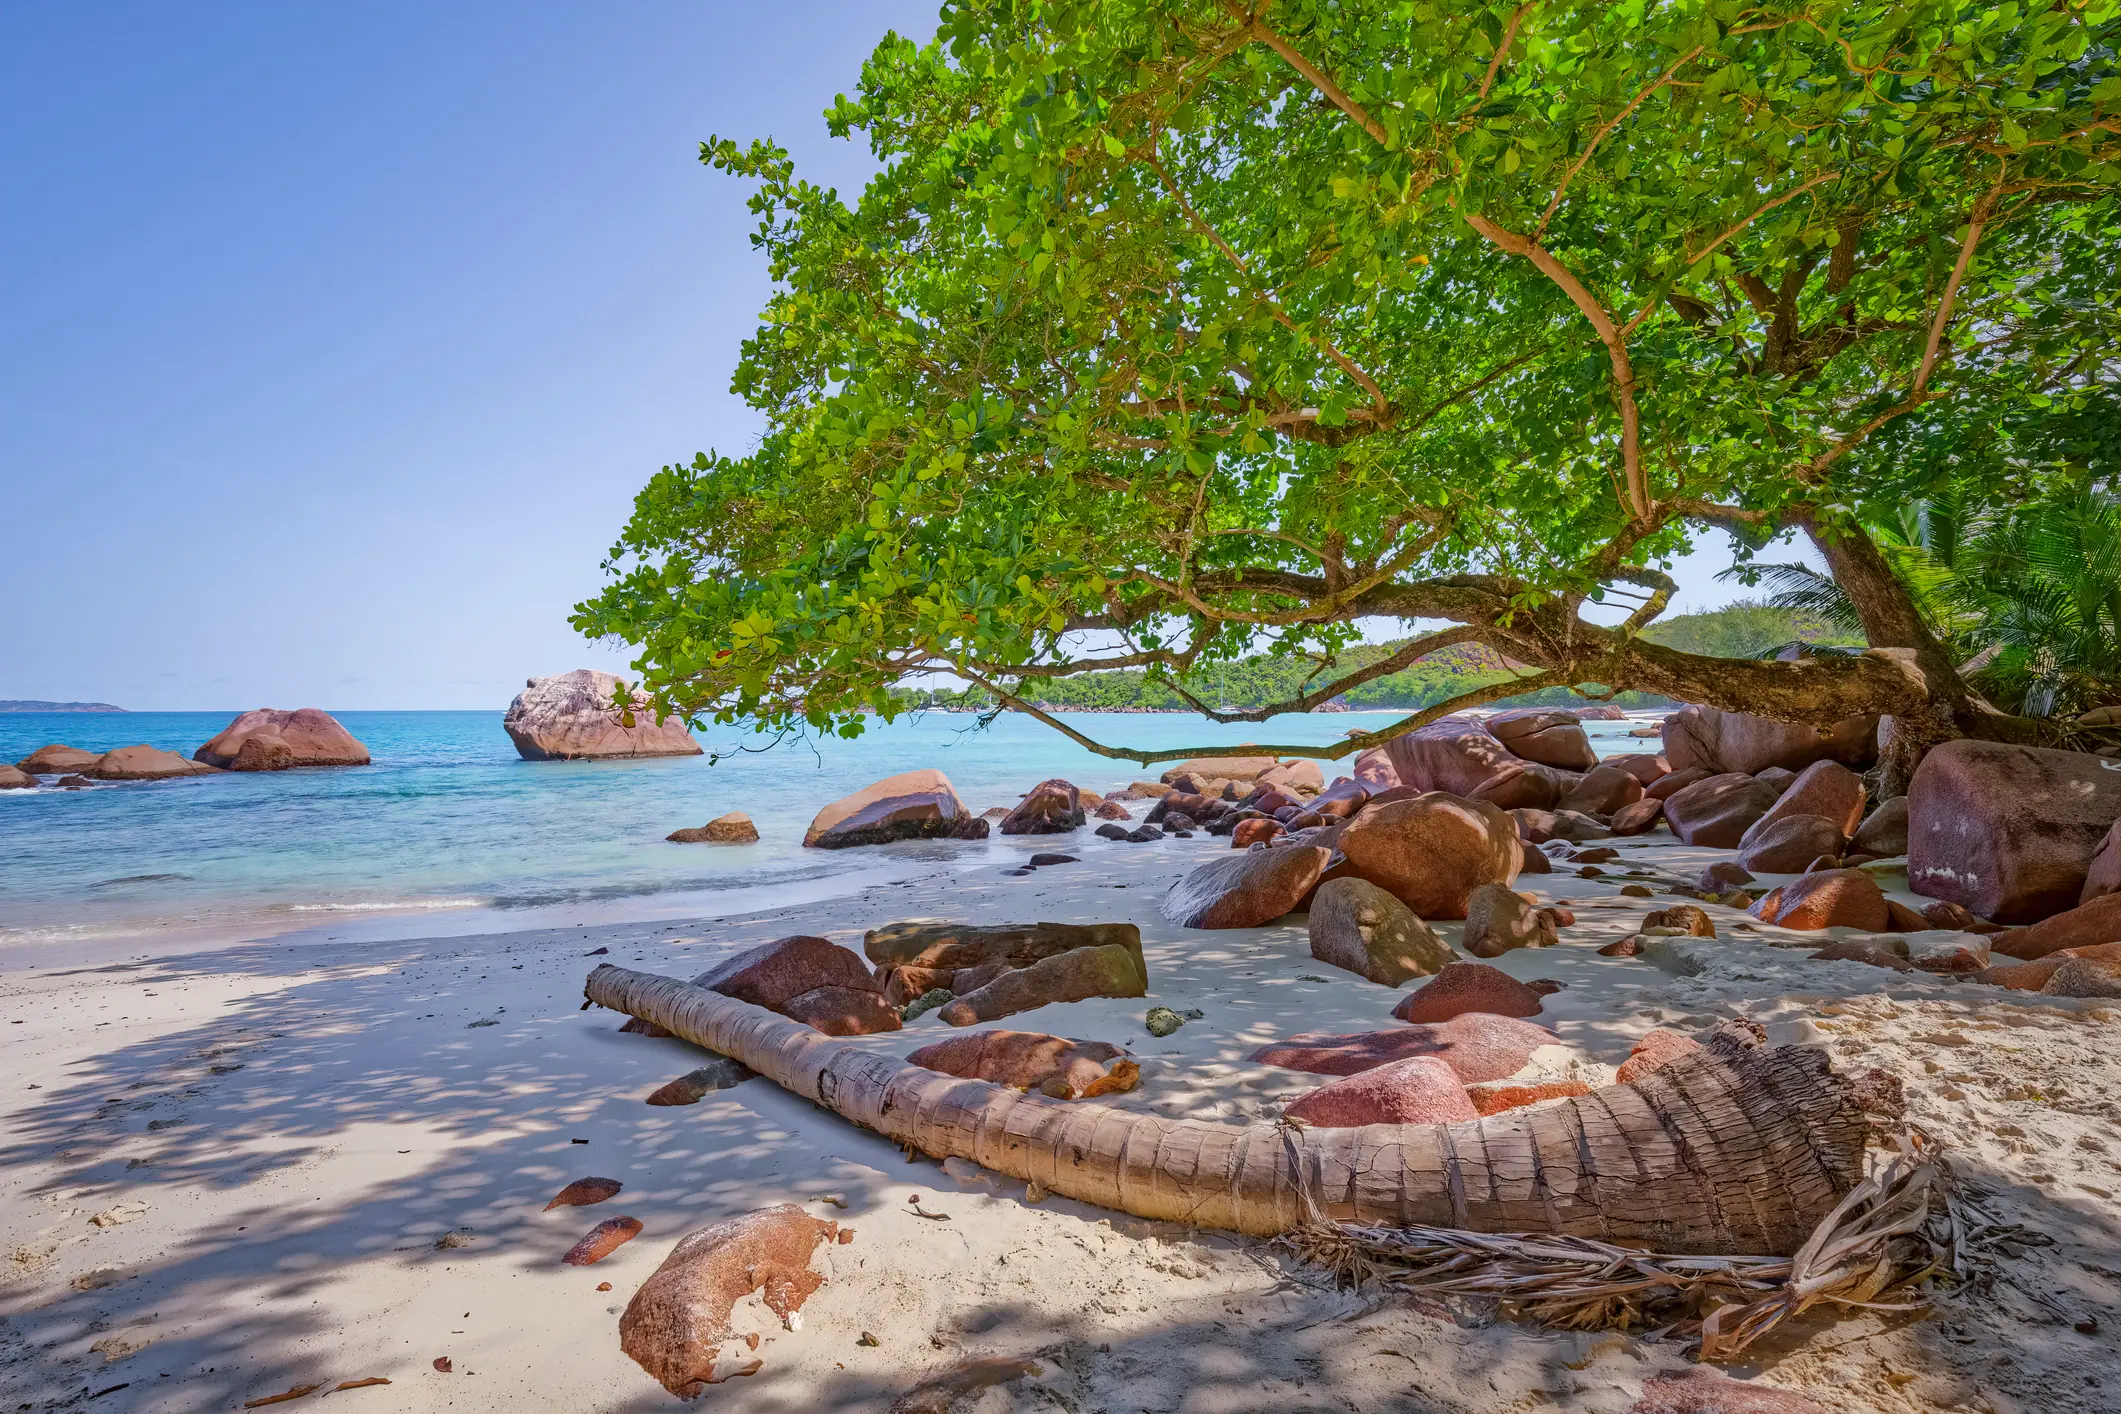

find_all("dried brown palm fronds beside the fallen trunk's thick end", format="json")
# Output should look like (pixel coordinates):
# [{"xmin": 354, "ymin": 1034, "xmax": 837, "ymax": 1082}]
[{"xmin": 1279, "ymin": 1136, "xmax": 1958, "ymax": 1359}]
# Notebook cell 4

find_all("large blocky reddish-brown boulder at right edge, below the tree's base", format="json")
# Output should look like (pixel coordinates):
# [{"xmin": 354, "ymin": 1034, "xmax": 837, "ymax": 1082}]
[{"xmin": 1907, "ymin": 740, "xmax": 2121, "ymax": 922}]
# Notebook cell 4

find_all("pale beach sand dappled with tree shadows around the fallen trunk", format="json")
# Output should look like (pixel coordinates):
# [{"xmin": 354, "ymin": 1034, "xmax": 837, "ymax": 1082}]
[{"xmin": 0, "ymin": 831, "xmax": 2121, "ymax": 1414}]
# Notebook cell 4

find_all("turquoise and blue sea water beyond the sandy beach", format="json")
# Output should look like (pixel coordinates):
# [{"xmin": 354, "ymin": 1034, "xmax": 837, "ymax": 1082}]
[{"xmin": 0, "ymin": 710, "xmax": 1640, "ymax": 945}]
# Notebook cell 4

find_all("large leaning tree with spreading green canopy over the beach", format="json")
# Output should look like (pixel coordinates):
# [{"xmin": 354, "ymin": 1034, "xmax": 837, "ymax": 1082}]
[{"xmin": 577, "ymin": 0, "xmax": 2121, "ymax": 784}]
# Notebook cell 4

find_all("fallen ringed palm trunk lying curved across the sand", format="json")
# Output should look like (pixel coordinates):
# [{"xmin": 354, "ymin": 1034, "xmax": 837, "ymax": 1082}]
[{"xmin": 583, "ymin": 965, "xmax": 1869, "ymax": 1255}]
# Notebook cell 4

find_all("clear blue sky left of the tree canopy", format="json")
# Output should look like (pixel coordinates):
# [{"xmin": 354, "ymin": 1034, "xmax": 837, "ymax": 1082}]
[{"xmin": 0, "ymin": 0, "xmax": 1798, "ymax": 708}]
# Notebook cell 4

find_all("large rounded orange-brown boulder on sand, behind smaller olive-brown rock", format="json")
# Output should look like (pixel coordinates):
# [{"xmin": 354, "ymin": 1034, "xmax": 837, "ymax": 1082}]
[{"xmin": 1338, "ymin": 791, "xmax": 1521, "ymax": 918}]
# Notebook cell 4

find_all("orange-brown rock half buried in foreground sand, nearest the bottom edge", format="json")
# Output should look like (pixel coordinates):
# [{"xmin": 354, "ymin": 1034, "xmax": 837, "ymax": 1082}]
[{"xmin": 619, "ymin": 1202, "xmax": 840, "ymax": 1399}]
